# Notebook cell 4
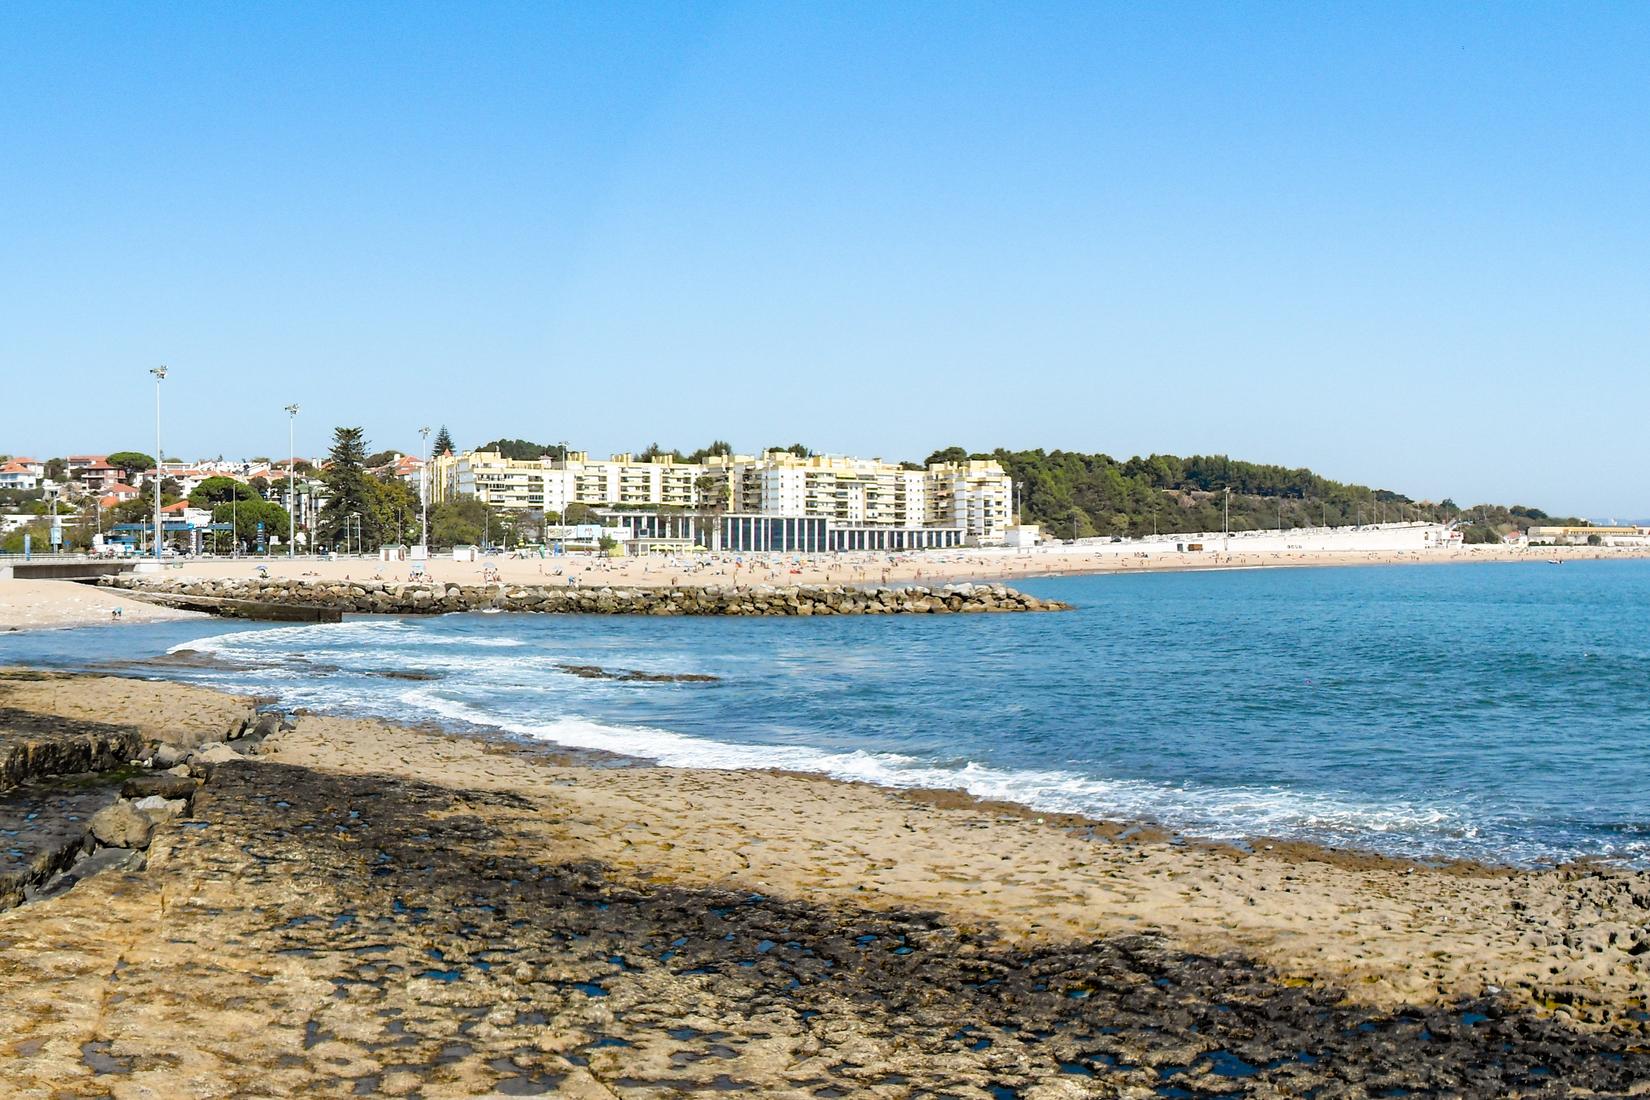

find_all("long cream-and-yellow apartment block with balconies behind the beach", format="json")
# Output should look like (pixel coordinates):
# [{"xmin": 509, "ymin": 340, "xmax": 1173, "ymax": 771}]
[{"xmin": 432, "ymin": 450, "xmax": 1013, "ymax": 543}]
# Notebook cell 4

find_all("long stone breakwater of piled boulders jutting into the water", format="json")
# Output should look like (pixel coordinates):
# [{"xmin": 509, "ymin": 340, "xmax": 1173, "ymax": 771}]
[{"xmin": 99, "ymin": 577, "xmax": 1069, "ymax": 615}]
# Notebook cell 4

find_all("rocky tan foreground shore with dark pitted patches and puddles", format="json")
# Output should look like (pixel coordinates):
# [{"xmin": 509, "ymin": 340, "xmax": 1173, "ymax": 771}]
[{"xmin": 0, "ymin": 675, "xmax": 1650, "ymax": 1100}]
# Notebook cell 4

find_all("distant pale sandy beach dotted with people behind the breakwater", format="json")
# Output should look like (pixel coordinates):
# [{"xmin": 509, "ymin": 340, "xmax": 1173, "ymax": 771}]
[{"xmin": 113, "ymin": 546, "xmax": 1650, "ymax": 592}]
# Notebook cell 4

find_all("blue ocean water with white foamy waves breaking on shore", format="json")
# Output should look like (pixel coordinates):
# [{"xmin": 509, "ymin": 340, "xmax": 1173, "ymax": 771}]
[{"xmin": 0, "ymin": 561, "xmax": 1650, "ymax": 866}]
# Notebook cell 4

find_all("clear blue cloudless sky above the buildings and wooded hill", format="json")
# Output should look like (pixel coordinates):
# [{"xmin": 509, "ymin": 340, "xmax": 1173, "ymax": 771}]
[{"xmin": 0, "ymin": 2, "xmax": 1650, "ymax": 516}]
